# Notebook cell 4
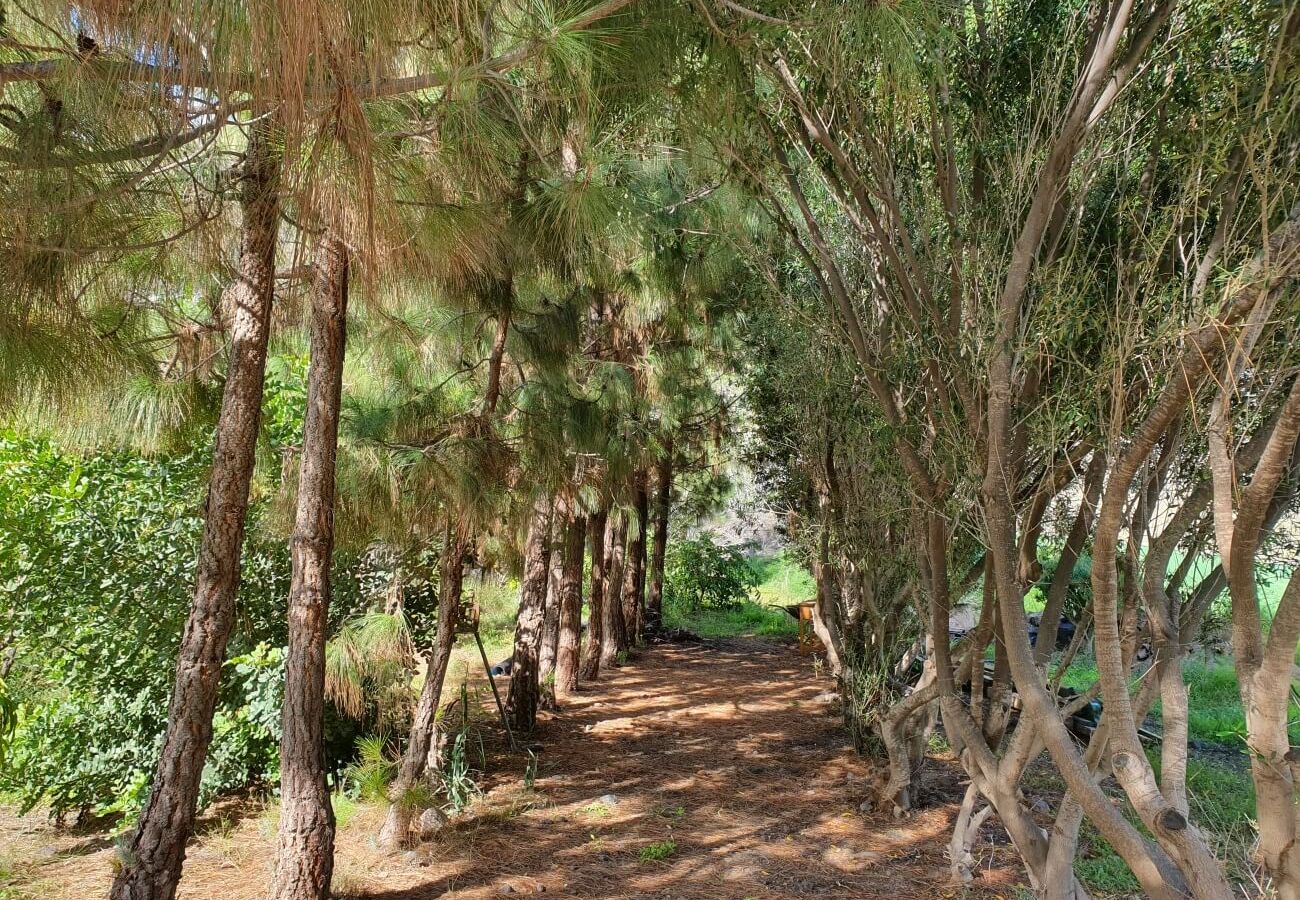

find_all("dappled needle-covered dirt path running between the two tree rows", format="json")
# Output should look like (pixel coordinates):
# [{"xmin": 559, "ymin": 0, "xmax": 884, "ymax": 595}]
[{"xmin": 341, "ymin": 641, "xmax": 1011, "ymax": 900}]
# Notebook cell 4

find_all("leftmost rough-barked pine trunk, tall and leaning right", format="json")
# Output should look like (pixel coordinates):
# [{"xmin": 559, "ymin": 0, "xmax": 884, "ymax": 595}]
[{"xmin": 111, "ymin": 125, "xmax": 280, "ymax": 900}]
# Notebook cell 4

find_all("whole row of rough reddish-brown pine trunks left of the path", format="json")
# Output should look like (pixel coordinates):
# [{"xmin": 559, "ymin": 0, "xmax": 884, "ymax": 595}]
[{"xmin": 112, "ymin": 128, "xmax": 673, "ymax": 900}]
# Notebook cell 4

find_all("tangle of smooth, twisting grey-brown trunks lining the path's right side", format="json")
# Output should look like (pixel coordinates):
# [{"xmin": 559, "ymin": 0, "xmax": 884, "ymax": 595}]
[{"xmin": 767, "ymin": 4, "xmax": 1300, "ymax": 900}]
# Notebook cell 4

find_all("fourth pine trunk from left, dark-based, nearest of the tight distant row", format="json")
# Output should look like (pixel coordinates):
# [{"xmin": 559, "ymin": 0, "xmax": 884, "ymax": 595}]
[{"xmin": 507, "ymin": 496, "xmax": 551, "ymax": 732}]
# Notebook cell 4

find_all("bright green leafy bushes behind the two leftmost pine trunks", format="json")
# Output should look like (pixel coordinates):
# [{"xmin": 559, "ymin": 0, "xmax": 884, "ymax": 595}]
[{"xmin": 0, "ymin": 433, "xmax": 371, "ymax": 818}]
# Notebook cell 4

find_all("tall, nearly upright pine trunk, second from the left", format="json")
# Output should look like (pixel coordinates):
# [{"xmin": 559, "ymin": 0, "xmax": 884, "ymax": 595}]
[{"xmin": 270, "ymin": 235, "xmax": 348, "ymax": 900}]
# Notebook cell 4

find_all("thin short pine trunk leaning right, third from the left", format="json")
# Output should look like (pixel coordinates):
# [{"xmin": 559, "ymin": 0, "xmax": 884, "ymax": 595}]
[{"xmin": 380, "ymin": 525, "xmax": 469, "ymax": 848}]
